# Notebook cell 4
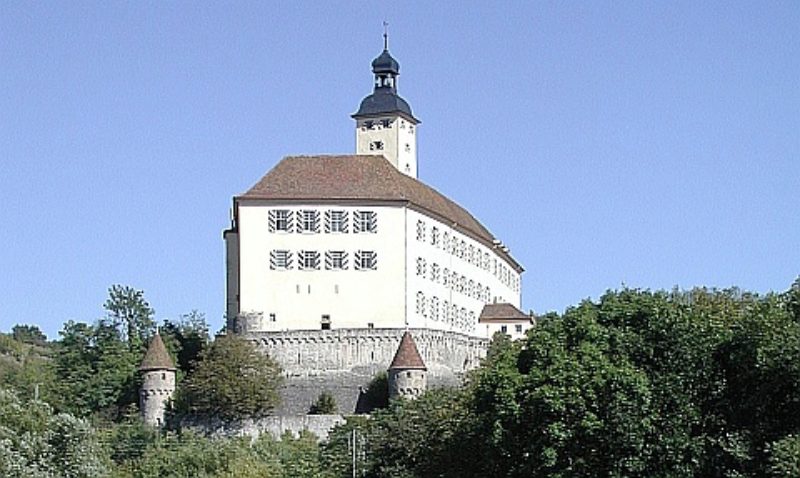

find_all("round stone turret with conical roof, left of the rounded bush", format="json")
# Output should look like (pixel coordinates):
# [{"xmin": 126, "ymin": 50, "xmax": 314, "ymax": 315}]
[{"xmin": 139, "ymin": 332, "xmax": 175, "ymax": 427}]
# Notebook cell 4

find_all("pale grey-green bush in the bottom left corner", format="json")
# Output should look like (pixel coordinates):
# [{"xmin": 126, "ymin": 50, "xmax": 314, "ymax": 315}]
[{"xmin": 0, "ymin": 390, "xmax": 108, "ymax": 478}]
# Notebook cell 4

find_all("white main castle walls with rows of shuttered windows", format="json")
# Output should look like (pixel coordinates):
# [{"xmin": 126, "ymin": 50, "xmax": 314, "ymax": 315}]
[{"xmin": 226, "ymin": 200, "xmax": 520, "ymax": 337}]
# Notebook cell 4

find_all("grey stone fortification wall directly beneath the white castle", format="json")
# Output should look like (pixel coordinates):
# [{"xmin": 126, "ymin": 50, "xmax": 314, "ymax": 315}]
[{"xmin": 247, "ymin": 329, "xmax": 489, "ymax": 415}]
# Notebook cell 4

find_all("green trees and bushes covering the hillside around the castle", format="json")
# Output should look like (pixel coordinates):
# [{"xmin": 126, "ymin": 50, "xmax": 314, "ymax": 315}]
[{"xmin": 0, "ymin": 280, "xmax": 800, "ymax": 478}]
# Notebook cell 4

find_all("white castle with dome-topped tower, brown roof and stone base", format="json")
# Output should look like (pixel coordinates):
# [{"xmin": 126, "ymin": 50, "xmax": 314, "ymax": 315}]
[{"xmin": 223, "ymin": 44, "xmax": 532, "ymax": 414}]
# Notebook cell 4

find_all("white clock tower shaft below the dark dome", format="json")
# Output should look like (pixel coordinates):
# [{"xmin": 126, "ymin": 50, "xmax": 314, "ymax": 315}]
[{"xmin": 356, "ymin": 115, "xmax": 417, "ymax": 178}]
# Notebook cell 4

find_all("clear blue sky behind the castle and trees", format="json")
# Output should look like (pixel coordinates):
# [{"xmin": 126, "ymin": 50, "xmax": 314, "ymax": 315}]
[{"xmin": 0, "ymin": 1, "xmax": 800, "ymax": 337}]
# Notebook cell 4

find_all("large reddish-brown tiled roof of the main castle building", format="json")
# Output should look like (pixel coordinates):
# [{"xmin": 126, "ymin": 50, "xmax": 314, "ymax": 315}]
[{"xmin": 236, "ymin": 155, "xmax": 523, "ymax": 272}]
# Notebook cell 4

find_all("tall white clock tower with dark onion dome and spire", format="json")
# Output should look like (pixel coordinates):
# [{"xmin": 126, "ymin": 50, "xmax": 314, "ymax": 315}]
[{"xmin": 352, "ymin": 32, "xmax": 419, "ymax": 178}]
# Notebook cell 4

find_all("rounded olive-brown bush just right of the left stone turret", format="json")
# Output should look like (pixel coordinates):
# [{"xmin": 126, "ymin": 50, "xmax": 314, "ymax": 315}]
[{"xmin": 175, "ymin": 335, "xmax": 282, "ymax": 420}]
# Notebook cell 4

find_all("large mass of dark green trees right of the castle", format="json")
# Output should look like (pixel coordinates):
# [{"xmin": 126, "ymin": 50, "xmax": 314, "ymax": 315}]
[{"xmin": 340, "ymin": 282, "xmax": 800, "ymax": 477}]
